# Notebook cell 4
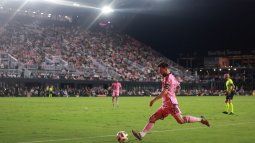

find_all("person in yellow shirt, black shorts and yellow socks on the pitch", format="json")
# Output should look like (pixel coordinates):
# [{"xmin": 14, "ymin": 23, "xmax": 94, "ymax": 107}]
[{"xmin": 222, "ymin": 74, "xmax": 235, "ymax": 115}]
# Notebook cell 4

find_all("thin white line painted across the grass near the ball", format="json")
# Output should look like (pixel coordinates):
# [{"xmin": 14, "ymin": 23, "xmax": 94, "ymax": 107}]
[{"xmin": 18, "ymin": 122, "xmax": 255, "ymax": 143}]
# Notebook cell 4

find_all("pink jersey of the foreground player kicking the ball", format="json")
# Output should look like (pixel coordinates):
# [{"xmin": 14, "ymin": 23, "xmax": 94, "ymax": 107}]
[{"xmin": 162, "ymin": 73, "xmax": 180, "ymax": 107}]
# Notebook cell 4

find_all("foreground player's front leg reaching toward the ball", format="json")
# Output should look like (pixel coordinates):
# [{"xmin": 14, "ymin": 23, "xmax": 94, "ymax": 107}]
[{"xmin": 132, "ymin": 108, "xmax": 167, "ymax": 140}]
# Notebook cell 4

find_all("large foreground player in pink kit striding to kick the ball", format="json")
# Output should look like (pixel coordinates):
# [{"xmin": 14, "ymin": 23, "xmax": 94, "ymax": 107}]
[{"xmin": 132, "ymin": 62, "xmax": 210, "ymax": 140}]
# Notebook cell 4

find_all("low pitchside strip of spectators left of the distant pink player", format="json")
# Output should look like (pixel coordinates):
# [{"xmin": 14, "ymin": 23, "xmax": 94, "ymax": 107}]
[{"xmin": 0, "ymin": 83, "xmax": 109, "ymax": 97}]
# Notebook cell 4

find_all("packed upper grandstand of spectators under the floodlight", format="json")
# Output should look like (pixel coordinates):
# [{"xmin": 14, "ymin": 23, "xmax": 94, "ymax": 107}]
[{"xmin": 0, "ymin": 13, "xmax": 191, "ymax": 81}]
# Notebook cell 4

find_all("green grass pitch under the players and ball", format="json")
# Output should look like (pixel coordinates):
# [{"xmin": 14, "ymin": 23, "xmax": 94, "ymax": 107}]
[{"xmin": 0, "ymin": 96, "xmax": 255, "ymax": 143}]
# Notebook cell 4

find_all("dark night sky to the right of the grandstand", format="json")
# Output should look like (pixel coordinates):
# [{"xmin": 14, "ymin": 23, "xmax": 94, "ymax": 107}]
[{"xmin": 116, "ymin": 0, "xmax": 255, "ymax": 59}]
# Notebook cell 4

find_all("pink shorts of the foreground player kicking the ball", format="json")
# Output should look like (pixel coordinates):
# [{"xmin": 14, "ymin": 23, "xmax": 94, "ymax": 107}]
[{"xmin": 151, "ymin": 104, "xmax": 181, "ymax": 120}]
